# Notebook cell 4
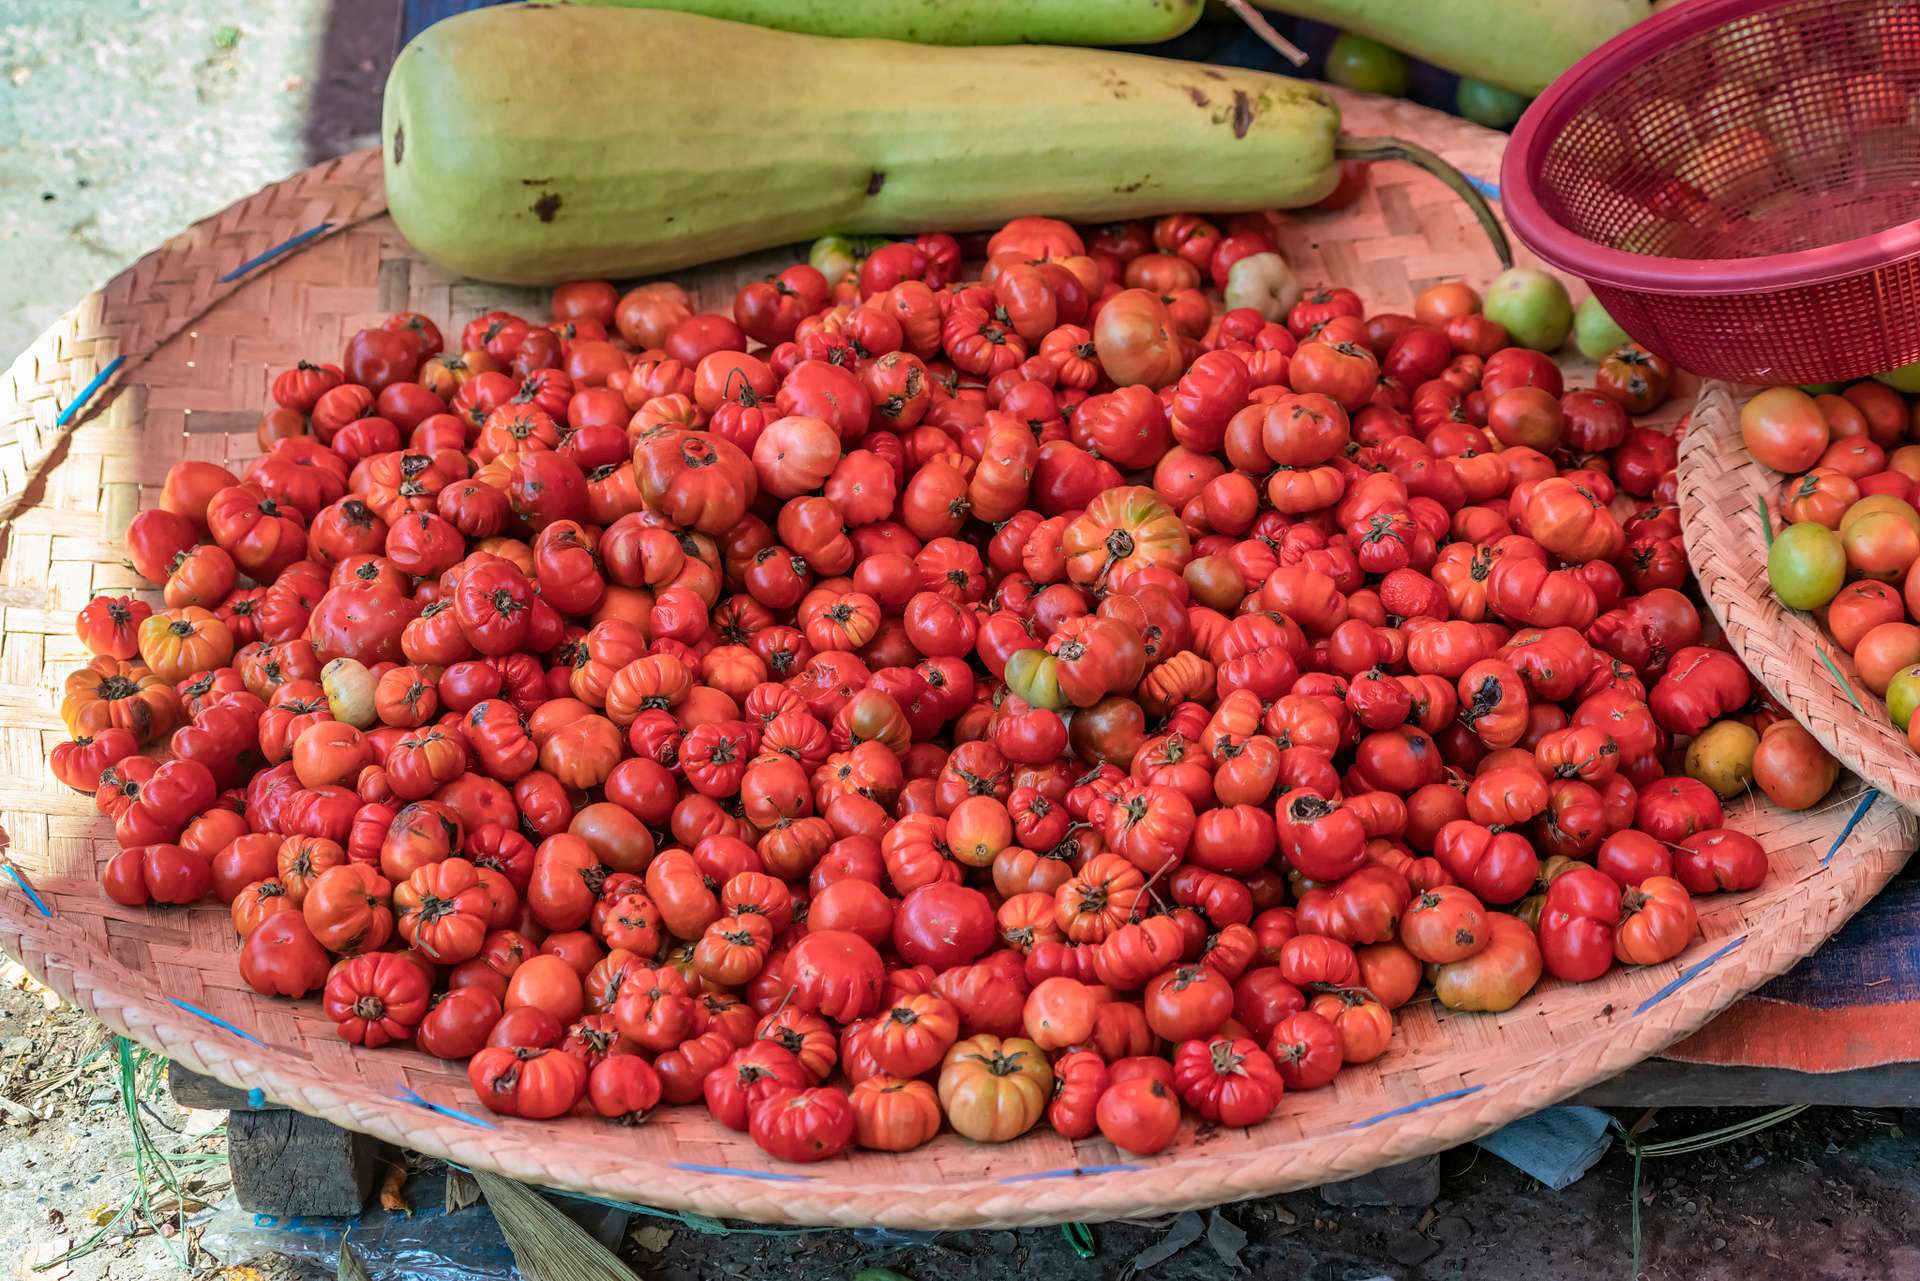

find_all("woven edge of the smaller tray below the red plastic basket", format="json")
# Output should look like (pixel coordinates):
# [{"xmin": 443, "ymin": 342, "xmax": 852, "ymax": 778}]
[{"xmin": 1680, "ymin": 382, "xmax": 1920, "ymax": 810}]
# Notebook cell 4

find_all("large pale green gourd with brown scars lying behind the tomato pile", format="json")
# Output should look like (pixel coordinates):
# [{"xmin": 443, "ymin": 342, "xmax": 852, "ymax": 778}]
[{"xmin": 382, "ymin": 6, "xmax": 1340, "ymax": 284}]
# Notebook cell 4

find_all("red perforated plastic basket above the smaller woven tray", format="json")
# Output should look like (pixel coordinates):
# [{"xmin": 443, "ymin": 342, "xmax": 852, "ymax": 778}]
[{"xmin": 1500, "ymin": 0, "xmax": 1920, "ymax": 382}]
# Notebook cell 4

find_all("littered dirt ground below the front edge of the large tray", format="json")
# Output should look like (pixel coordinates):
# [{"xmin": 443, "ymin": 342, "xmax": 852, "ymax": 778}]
[{"xmin": 0, "ymin": 968, "xmax": 1920, "ymax": 1281}]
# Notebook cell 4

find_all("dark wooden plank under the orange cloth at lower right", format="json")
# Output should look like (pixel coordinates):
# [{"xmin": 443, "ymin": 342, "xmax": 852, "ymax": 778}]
[{"xmin": 1567, "ymin": 1058, "xmax": 1920, "ymax": 1108}]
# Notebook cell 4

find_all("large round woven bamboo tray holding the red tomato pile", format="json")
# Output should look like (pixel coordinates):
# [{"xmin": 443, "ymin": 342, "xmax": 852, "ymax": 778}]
[{"xmin": 0, "ymin": 96, "xmax": 1914, "ymax": 1227}]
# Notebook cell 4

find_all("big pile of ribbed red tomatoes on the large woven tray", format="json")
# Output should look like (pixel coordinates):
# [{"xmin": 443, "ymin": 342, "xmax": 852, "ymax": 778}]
[{"xmin": 52, "ymin": 197, "xmax": 1812, "ymax": 1160}]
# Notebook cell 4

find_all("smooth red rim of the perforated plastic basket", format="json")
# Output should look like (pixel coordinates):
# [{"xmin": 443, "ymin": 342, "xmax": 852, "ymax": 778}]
[{"xmin": 1500, "ymin": 0, "xmax": 1920, "ymax": 294}]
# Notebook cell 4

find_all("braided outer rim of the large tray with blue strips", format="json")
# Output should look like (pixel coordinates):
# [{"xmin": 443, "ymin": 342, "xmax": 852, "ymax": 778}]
[{"xmin": 0, "ymin": 94, "xmax": 1916, "ymax": 1227}]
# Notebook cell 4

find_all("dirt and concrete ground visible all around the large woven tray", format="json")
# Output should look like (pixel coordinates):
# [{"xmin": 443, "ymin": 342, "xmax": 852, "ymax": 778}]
[{"xmin": 11, "ymin": 0, "xmax": 1920, "ymax": 1281}]
